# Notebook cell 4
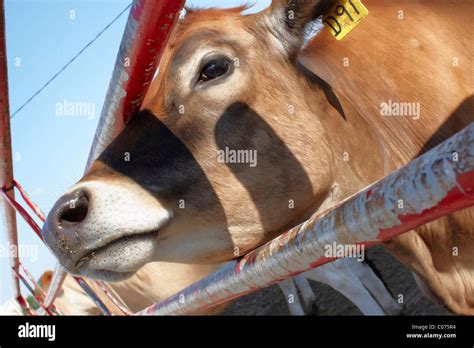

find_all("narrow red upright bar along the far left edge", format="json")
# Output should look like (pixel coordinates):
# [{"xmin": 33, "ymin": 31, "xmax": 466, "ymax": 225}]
[{"xmin": 0, "ymin": 0, "xmax": 21, "ymax": 298}]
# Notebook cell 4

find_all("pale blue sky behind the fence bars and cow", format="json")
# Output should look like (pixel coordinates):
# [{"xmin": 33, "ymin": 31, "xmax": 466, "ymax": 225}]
[{"xmin": 0, "ymin": 0, "xmax": 270, "ymax": 303}]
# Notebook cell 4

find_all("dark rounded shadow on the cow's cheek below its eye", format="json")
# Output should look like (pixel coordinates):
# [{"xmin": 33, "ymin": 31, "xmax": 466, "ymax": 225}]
[{"xmin": 214, "ymin": 102, "xmax": 313, "ymax": 232}]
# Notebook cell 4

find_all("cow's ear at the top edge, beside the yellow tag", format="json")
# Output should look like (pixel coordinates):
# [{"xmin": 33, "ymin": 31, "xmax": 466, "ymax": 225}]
[{"xmin": 262, "ymin": 0, "xmax": 335, "ymax": 57}]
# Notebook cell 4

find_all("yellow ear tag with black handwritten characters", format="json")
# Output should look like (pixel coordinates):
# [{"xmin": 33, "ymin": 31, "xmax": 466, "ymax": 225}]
[{"xmin": 323, "ymin": 0, "xmax": 369, "ymax": 40}]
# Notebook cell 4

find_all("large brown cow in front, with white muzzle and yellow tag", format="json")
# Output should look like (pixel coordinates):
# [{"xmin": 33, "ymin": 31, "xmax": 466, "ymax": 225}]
[{"xmin": 43, "ymin": 0, "xmax": 474, "ymax": 314}]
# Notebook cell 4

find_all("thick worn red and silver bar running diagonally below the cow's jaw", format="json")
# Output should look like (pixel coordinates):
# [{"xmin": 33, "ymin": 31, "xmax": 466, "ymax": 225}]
[{"xmin": 137, "ymin": 123, "xmax": 474, "ymax": 315}]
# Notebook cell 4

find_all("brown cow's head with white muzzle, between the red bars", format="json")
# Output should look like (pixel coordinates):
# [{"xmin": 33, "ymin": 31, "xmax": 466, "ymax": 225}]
[{"xmin": 43, "ymin": 1, "xmax": 332, "ymax": 280}]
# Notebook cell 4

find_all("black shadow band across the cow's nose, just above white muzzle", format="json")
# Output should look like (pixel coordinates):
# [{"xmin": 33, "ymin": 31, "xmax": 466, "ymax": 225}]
[{"xmin": 85, "ymin": 110, "xmax": 225, "ymax": 221}]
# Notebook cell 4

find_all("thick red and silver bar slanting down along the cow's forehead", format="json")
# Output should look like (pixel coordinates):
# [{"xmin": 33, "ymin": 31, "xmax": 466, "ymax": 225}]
[{"xmin": 47, "ymin": 0, "xmax": 185, "ymax": 310}]
